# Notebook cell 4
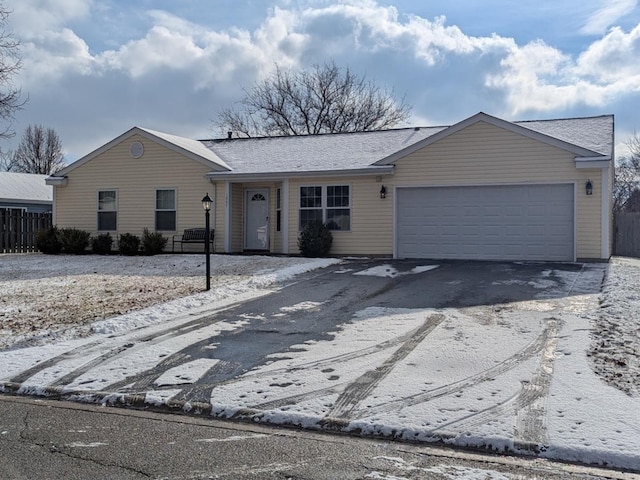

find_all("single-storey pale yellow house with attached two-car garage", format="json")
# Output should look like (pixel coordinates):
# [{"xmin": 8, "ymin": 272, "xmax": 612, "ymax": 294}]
[{"xmin": 47, "ymin": 113, "xmax": 614, "ymax": 261}]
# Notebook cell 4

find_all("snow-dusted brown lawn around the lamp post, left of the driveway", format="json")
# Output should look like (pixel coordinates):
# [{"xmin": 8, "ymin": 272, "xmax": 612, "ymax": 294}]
[{"xmin": 0, "ymin": 254, "xmax": 337, "ymax": 350}]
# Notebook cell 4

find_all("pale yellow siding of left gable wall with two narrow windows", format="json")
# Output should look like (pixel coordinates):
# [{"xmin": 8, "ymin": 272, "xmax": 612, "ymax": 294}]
[{"xmin": 56, "ymin": 135, "xmax": 212, "ymax": 248}]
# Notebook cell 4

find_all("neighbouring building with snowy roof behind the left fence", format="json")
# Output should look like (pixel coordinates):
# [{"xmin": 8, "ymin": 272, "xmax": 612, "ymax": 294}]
[{"xmin": 0, "ymin": 172, "xmax": 53, "ymax": 213}]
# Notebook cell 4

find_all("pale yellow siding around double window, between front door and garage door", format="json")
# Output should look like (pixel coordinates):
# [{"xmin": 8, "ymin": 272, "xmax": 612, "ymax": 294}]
[{"xmin": 283, "ymin": 176, "xmax": 393, "ymax": 255}]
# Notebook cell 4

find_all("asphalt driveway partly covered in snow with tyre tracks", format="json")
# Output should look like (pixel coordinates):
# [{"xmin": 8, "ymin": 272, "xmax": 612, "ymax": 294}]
[{"xmin": 1, "ymin": 260, "xmax": 624, "ymax": 468}]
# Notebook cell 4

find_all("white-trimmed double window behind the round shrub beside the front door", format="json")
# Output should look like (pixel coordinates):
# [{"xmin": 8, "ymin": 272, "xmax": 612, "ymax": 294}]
[{"xmin": 299, "ymin": 185, "xmax": 351, "ymax": 231}]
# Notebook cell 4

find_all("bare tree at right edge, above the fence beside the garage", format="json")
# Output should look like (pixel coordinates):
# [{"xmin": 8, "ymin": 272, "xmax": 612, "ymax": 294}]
[{"xmin": 613, "ymin": 132, "xmax": 640, "ymax": 212}]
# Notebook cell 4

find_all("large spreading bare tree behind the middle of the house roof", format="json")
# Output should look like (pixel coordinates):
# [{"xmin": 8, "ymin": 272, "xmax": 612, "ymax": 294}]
[{"xmin": 216, "ymin": 63, "xmax": 411, "ymax": 137}]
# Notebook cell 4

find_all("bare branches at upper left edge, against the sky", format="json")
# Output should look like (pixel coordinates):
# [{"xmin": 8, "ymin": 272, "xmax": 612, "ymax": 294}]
[{"xmin": 0, "ymin": 3, "xmax": 25, "ymax": 138}]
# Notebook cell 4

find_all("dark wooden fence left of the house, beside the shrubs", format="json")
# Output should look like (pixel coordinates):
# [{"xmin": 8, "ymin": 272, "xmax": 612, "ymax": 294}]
[{"xmin": 0, "ymin": 208, "xmax": 51, "ymax": 253}]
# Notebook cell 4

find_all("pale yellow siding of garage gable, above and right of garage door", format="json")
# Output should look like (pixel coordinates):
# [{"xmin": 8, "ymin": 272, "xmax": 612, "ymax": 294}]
[{"xmin": 389, "ymin": 122, "xmax": 601, "ymax": 258}]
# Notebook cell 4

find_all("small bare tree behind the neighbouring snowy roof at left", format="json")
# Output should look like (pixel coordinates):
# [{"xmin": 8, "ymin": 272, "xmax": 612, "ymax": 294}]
[{"xmin": 5, "ymin": 125, "xmax": 66, "ymax": 175}]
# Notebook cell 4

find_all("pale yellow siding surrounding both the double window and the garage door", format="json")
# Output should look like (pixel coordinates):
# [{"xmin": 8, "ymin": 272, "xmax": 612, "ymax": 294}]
[{"xmin": 288, "ymin": 122, "xmax": 602, "ymax": 258}]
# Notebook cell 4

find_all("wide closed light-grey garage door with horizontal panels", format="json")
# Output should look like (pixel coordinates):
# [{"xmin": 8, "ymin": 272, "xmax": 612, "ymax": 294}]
[{"xmin": 396, "ymin": 184, "xmax": 574, "ymax": 261}]
